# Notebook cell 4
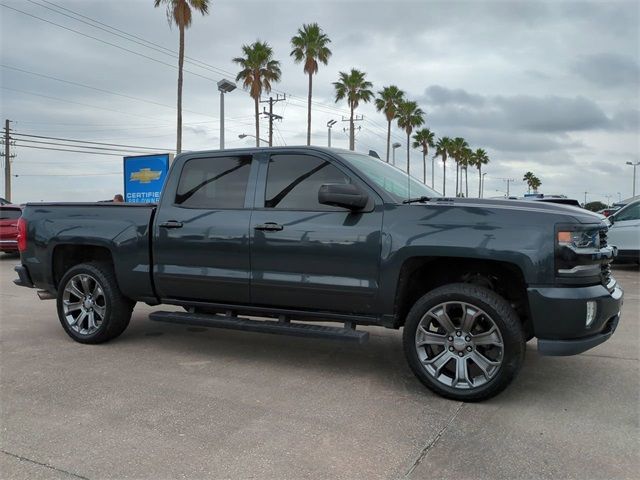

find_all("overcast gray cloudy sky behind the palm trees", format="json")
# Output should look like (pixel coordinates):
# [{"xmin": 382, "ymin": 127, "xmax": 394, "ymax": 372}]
[{"xmin": 0, "ymin": 0, "xmax": 640, "ymax": 202}]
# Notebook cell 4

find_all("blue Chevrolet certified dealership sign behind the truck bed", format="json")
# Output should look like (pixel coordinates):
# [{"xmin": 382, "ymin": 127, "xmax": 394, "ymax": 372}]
[{"xmin": 124, "ymin": 153, "xmax": 171, "ymax": 203}]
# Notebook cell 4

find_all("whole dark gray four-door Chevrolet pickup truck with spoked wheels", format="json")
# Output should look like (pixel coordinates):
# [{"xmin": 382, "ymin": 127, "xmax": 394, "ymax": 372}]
[{"xmin": 15, "ymin": 147, "xmax": 623, "ymax": 401}]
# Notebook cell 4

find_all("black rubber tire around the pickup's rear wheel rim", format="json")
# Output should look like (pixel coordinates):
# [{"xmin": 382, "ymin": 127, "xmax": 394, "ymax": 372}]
[{"xmin": 56, "ymin": 262, "xmax": 135, "ymax": 344}]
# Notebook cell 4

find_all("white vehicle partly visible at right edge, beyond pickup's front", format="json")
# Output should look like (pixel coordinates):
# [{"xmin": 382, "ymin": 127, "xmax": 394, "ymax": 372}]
[{"xmin": 608, "ymin": 200, "xmax": 640, "ymax": 264}]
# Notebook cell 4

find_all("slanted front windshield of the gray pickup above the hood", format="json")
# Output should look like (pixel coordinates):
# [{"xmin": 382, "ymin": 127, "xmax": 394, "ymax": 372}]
[{"xmin": 340, "ymin": 153, "xmax": 442, "ymax": 203}]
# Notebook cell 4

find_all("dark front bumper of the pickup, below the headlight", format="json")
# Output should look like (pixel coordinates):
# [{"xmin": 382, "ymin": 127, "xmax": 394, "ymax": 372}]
[{"xmin": 528, "ymin": 279, "xmax": 624, "ymax": 355}]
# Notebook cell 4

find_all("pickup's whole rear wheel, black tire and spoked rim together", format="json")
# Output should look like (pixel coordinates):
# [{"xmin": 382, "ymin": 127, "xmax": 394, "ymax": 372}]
[{"xmin": 57, "ymin": 263, "xmax": 135, "ymax": 344}]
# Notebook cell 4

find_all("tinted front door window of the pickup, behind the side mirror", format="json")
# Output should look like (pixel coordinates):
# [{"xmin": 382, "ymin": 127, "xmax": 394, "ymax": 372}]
[{"xmin": 264, "ymin": 155, "xmax": 350, "ymax": 210}]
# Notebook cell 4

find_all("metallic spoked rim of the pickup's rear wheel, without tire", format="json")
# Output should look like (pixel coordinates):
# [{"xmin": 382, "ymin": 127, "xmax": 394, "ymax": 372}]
[{"xmin": 62, "ymin": 273, "xmax": 107, "ymax": 335}]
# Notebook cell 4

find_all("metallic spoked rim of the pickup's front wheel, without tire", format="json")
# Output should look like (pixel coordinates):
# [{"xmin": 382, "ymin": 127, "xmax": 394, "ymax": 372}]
[{"xmin": 415, "ymin": 301, "xmax": 504, "ymax": 390}]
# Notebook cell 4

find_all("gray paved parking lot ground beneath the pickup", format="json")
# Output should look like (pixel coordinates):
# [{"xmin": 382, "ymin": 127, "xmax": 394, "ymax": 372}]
[{"xmin": 0, "ymin": 256, "xmax": 640, "ymax": 479}]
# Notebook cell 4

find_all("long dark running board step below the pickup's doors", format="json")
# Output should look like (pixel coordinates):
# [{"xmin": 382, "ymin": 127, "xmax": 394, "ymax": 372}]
[{"xmin": 149, "ymin": 311, "xmax": 369, "ymax": 344}]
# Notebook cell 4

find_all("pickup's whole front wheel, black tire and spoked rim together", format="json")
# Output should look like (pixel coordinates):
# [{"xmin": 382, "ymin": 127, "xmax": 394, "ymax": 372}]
[{"xmin": 403, "ymin": 283, "xmax": 525, "ymax": 401}]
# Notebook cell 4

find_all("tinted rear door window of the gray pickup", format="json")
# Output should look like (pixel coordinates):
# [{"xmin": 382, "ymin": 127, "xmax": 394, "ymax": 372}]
[{"xmin": 176, "ymin": 157, "xmax": 251, "ymax": 208}]
